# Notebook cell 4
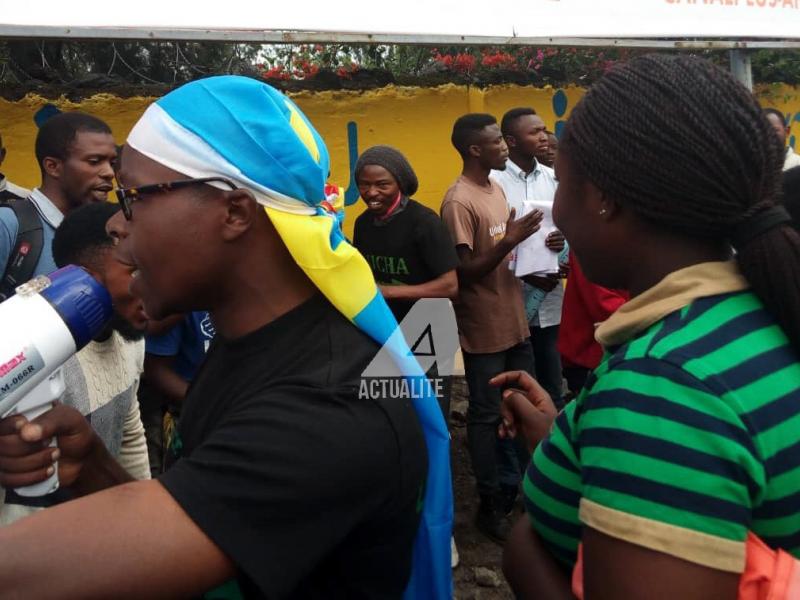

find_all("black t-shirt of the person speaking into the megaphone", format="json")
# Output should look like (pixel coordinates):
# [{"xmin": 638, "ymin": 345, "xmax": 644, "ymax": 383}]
[{"xmin": 160, "ymin": 295, "xmax": 427, "ymax": 599}]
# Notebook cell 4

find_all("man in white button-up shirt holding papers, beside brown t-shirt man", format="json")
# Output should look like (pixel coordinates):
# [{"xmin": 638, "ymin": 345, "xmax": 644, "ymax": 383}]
[{"xmin": 491, "ymin": 108, "xmax": 564, "ymax": 406}]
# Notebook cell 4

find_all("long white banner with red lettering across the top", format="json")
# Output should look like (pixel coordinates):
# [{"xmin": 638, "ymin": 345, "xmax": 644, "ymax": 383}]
[{"xmin": 0, "ymin": 0, "xmax": 800, "ymax": 43}]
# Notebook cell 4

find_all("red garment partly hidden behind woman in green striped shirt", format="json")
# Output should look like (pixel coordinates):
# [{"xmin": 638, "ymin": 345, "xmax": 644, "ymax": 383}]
[{"xmin": 558, "ymin": 253, "xmax": 629, "ymax": 369}]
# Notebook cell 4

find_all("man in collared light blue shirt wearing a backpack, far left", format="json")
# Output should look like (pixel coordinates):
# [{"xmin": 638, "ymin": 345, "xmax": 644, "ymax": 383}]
[{"xmin": 0, "ymin": 112, "xmax": 117, "ymax": 290}]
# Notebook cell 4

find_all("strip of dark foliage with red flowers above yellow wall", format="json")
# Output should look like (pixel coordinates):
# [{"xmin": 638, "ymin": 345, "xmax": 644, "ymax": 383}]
[{"xmin": 0, "ymin": 40, "xmax": 800, "ymax": 87}]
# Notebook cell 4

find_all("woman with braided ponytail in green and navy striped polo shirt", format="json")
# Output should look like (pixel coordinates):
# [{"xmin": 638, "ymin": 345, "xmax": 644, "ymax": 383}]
[{"xmin": 493, "ymin": 55, "xmax": 800, "ymax": 600}]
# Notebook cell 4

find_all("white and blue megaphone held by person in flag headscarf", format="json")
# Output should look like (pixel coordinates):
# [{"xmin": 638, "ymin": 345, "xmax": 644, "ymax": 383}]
[{"xmin": 0, "ymin": 265, "xmax": 112, "ymax": 496}]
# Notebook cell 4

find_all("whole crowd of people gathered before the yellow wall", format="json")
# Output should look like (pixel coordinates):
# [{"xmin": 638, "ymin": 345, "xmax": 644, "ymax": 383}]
[{"xmin": 0, "ymin": 55, "xmax": 800, "ymax": 600}]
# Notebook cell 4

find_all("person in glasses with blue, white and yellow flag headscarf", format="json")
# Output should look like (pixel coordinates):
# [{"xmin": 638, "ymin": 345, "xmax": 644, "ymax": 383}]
[{"xmin": 0, "ymin": 77, "xmax": 452, "ymax": 598}]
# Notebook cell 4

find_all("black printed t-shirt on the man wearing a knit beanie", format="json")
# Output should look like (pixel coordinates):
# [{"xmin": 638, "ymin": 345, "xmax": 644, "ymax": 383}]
[{"xmin": 353, "ymin": 199, "xmax": 458, "ymax": 321}]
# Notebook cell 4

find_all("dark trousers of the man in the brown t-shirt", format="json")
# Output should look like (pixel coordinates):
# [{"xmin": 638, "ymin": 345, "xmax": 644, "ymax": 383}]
[{"xmin": 462, "ymin": 340, "xmax": 533, "ymax": 496}]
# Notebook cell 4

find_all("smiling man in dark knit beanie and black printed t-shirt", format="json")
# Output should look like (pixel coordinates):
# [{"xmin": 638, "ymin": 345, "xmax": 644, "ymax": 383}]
[{"xmin": 353, "ymin": 146, "xmax": 458, "ymax": 322}]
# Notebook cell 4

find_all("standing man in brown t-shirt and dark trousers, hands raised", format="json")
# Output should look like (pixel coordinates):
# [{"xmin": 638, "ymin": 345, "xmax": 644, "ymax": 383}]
[{"xmin": 441, "ymin": 114, "xmax": 542, "ymax": 542}]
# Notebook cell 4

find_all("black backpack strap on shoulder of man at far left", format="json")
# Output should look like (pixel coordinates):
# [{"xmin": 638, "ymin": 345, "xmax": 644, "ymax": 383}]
[{"xmin": 0, "ymin": 194, "xmax": 44, "ymax": 302}]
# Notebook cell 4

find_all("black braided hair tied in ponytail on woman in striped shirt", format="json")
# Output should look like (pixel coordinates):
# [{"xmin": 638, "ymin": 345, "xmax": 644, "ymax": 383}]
[{"xmin": 561, "ymin": 55, "xmax": 800, "ymax": 351}]
